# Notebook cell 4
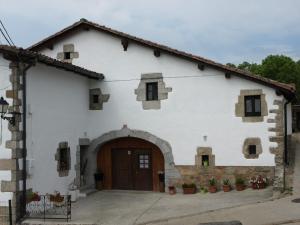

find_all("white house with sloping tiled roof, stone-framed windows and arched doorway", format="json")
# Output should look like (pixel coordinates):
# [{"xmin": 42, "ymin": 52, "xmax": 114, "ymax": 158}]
[{"xmin": 0, "ymin": 19, "xmax": 295, "ymax": 223}]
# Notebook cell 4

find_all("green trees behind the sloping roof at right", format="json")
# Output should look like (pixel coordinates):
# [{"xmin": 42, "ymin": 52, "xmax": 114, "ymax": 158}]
[{"xmin": 227, "ymin": 55, "xmax": 300, "ymax": 101}]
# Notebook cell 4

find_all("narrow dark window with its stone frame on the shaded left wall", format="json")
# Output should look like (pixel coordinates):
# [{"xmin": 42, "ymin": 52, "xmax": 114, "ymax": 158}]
[{"xmin": 55, "ymin": 142, "xmax": 71, "ymax": 177}]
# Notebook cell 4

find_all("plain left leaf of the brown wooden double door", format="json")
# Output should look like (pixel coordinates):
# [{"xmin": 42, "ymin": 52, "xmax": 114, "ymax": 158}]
[{"xmin": 112, "ymin": 149, "xmax": 133, "ymax": 190}]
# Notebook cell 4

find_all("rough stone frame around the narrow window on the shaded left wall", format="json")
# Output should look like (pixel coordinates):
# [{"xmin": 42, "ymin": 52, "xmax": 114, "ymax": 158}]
[{"xmin": 55, "ymin": 142, "xmax": 71, "ymax": 177}]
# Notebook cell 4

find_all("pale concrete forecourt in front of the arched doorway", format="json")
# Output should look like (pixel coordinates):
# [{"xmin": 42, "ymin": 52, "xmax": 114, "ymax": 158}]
[{"xmin": 22, "ymin": 188, "xmax": 272, "ymax": 225}]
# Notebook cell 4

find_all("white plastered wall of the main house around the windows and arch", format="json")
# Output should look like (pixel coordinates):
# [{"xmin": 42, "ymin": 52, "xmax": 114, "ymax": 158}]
[{"xmin": 27, "ymin": 30, "xmax": 288, "ymax": 192}]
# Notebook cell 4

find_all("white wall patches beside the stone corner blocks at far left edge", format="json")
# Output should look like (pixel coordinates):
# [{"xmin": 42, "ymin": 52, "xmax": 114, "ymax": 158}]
[{"xmin": 0, "ymin": 54, "xmax": 11, "ymax": 205}]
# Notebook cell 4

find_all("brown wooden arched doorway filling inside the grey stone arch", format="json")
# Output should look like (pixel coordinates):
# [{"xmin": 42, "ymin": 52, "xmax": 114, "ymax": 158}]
[{"xmin": 97, "ymin": 137, "xmax": 165, "ymax": 191}]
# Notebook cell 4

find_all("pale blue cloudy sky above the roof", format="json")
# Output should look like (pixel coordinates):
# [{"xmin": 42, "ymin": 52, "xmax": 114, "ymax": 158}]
[{"xmin": 0, "ymin": 0, "xmax": 300, "ymax": 63}]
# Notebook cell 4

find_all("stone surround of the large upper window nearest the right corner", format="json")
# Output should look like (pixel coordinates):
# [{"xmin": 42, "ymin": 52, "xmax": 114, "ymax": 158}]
[{"xmin": 235, "ymin": 89, "xmax": 268, "ymax": 123}]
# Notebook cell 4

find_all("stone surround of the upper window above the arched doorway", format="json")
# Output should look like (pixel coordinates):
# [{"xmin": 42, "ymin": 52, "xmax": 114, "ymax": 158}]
[{"xmin": 134, "ymin": 73, "xmax": 172, "ymax": 110}]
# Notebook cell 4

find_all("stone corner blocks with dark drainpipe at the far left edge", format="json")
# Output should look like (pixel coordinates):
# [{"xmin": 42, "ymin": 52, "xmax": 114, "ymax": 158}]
[{"xmin": 0, "ymin": 62, "xmax": 25, "ymax": 225}]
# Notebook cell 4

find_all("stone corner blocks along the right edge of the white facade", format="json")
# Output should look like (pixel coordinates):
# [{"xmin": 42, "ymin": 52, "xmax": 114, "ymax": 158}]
[{"xmin": 268, "ymin": 100, "xmax": 285, "ymax": 192}]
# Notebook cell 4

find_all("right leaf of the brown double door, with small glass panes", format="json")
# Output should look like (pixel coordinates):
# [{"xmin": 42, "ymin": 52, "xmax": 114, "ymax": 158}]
[{"xmin": 132, "ymin": 149, "xmax": 153, "ymax": 191}]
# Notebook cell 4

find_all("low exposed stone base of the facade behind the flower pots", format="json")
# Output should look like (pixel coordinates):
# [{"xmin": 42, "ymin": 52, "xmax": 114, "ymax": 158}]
[{"xmin": 171, "ymin": 165, "xmax": 275, "ymax": 190}]
